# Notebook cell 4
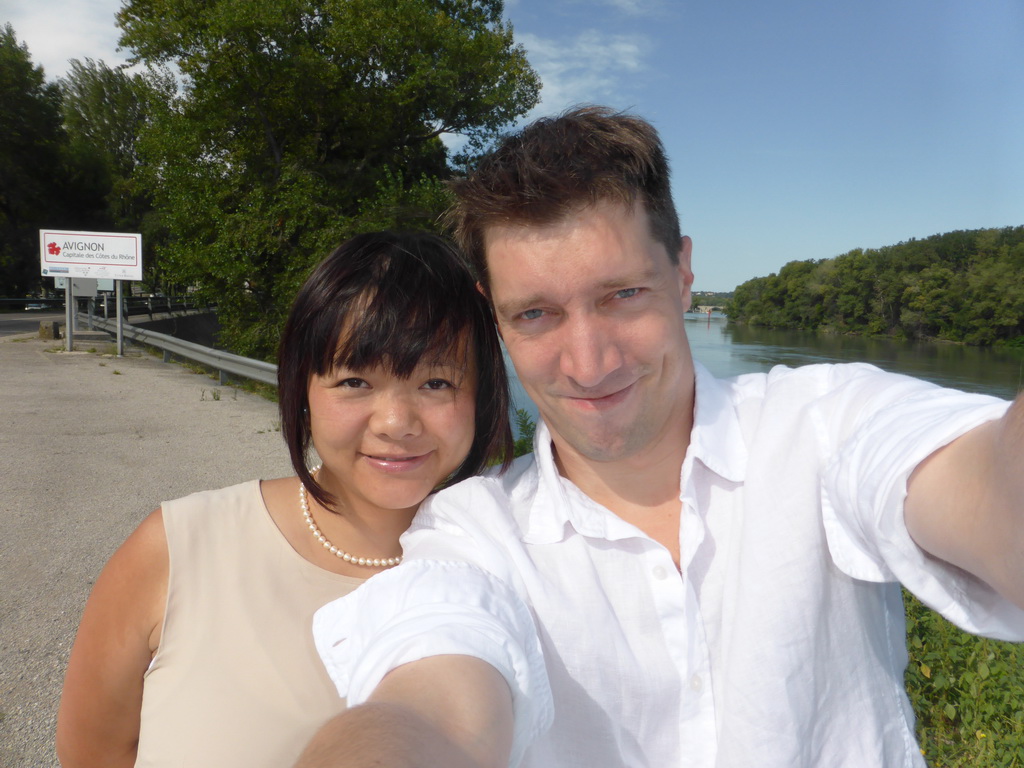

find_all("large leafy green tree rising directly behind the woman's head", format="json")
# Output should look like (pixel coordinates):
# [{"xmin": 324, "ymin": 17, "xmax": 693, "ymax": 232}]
[{"xmin": 118, "ymin": 0, "xmax": 539, "ymax": 355}]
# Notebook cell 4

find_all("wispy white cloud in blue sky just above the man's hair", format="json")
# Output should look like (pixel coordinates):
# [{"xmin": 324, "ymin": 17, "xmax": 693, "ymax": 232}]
[{"xmin": 517, "ymin": 30, "xmax": 650, "ymax": 119}]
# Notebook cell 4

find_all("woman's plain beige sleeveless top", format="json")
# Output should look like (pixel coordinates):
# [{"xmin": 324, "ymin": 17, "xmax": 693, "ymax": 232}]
[{"xmin": 135, "ymin": 480, "xmax": 361, "ymax": 768}]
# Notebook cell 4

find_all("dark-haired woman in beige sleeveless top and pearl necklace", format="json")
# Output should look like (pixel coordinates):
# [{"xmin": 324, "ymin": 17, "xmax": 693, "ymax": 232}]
[{"xmin": 57, "ymin": 232, "xmax": 512, "ymax": 768}]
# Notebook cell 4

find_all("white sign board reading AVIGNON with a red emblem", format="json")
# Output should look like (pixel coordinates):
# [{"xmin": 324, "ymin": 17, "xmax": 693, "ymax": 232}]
[{"xmin": 39, "ymin": 229, "xmax": 142, "ymax": 280}]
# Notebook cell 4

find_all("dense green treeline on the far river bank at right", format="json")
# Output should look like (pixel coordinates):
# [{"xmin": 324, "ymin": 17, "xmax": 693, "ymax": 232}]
[{"xmin": 728, "ymin": 226, "xmax": 1024, "ymax": 346}]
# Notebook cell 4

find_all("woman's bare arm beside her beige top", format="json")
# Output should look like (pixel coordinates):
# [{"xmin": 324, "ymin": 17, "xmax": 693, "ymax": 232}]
[{"xmin": 56, "ymin": 509, "xmax": 169, "ymax": 768}]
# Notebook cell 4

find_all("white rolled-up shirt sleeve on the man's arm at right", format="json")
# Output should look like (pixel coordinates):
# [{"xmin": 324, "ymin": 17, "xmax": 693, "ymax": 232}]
[{"xmin": 821, "ymin": 387, "xmax": 1024, "ymax": 640}]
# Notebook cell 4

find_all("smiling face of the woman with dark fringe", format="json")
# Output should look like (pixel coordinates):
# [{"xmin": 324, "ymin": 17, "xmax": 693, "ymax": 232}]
[{"xmin": 308, "ymin": 348, "xmax": 477, "ymax": 512}]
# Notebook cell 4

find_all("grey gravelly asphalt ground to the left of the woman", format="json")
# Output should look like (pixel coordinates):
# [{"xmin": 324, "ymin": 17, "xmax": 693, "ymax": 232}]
[{"xmin": 0, "ymin": 325, "xmax": 298, "ymax": 768}]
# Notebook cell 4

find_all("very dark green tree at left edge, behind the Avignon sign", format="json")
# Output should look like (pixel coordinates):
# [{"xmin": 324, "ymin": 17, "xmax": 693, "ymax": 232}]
[{"xmin": 0, "ymin": 24, "xmax": 65, "ymax": 296}]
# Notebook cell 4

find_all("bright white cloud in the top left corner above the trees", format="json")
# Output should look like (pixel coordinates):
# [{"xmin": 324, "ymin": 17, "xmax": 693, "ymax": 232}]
[{"xmin": 0, "ymin": 0, "xmax": 126, "ymax": 80}]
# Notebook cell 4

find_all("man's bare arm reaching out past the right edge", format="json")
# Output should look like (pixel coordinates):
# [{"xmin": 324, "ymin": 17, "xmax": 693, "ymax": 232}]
[{"xmin": 905, "ymin": 393, "xmax": 1024, "ymax": 608}]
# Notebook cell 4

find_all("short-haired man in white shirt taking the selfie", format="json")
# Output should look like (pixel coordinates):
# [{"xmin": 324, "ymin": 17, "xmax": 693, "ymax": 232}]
[{"xmin": 302, "ymin": 108, "xmax": 1024, "ymax": 768}]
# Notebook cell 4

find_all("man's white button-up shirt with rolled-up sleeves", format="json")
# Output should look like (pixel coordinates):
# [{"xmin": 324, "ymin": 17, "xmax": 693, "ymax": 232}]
[{"xmin": 314, "ymin": 365, "xmax": 1024, "ymax": 768}]
